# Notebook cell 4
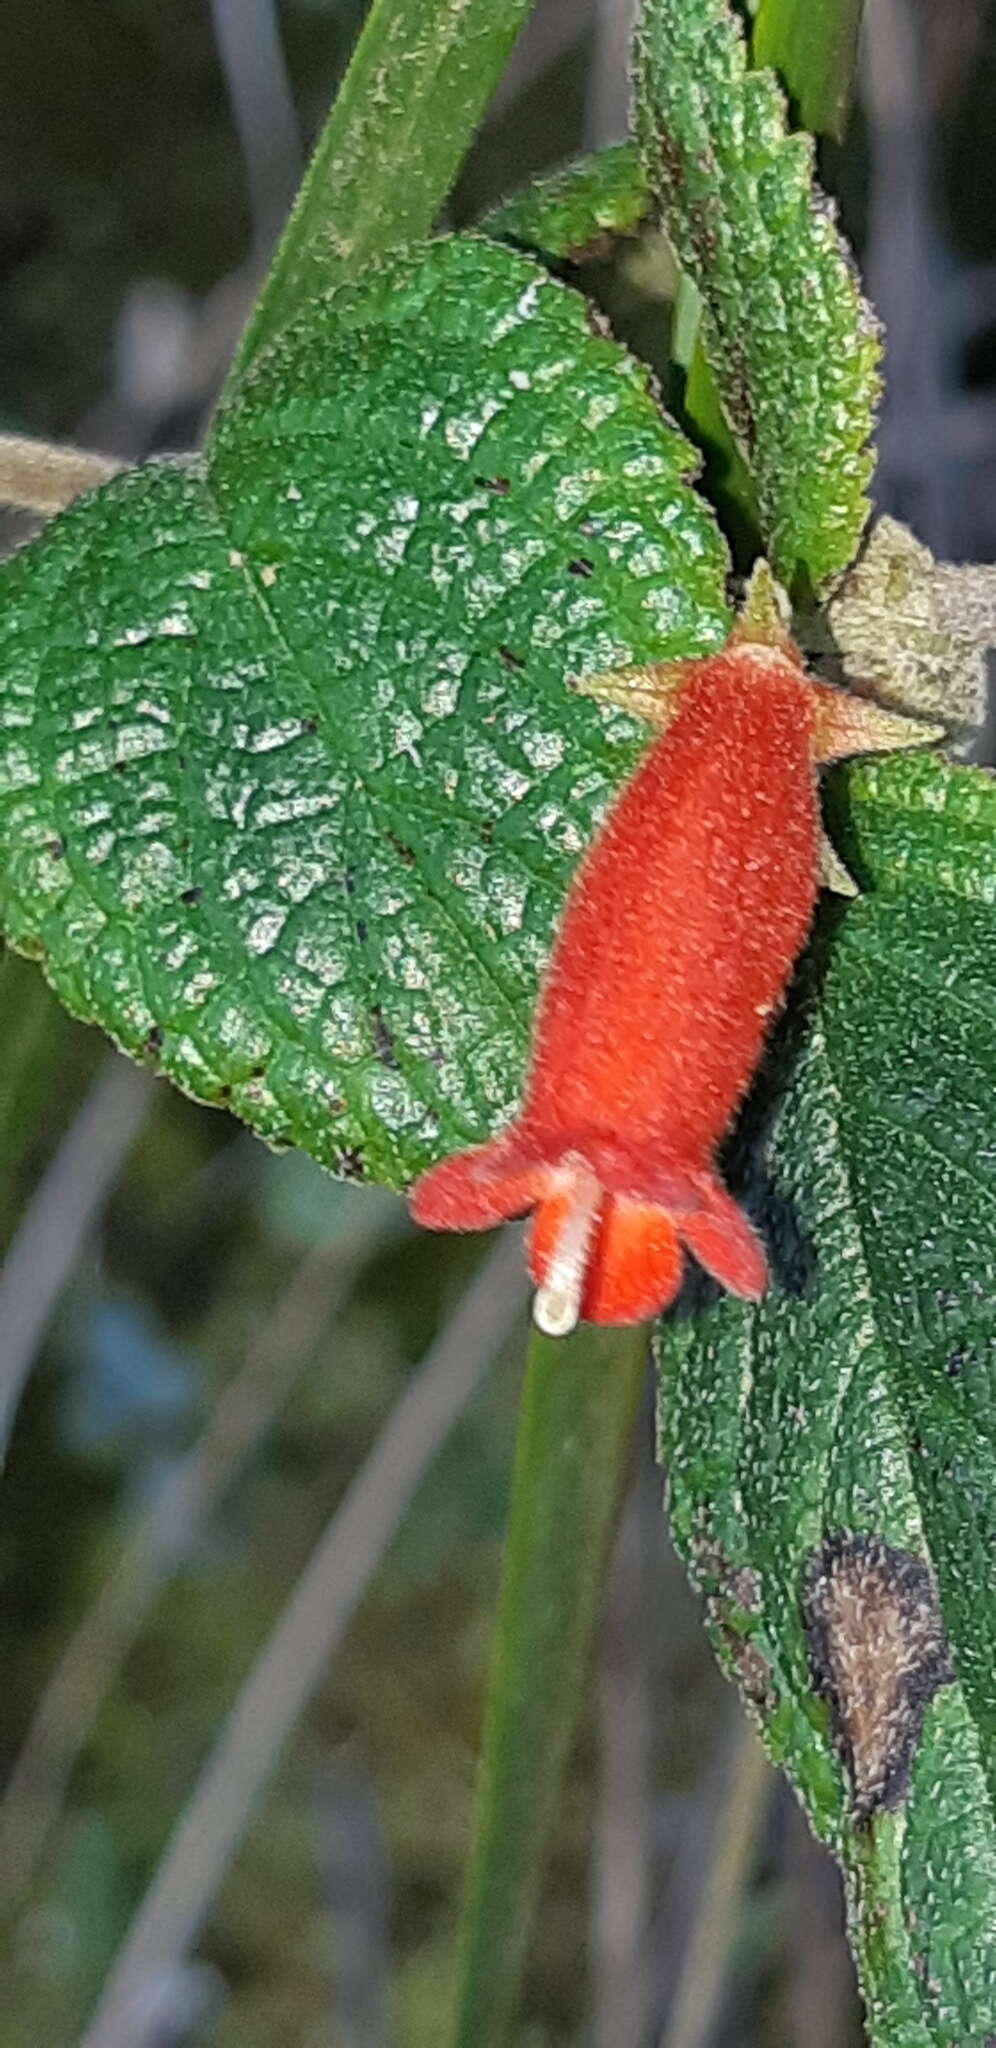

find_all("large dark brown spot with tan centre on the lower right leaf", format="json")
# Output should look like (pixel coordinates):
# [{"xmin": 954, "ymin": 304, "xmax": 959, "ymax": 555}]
[{"xmin": 801, "ymin": 1530, "xmax": 955, "ymax": 1827}]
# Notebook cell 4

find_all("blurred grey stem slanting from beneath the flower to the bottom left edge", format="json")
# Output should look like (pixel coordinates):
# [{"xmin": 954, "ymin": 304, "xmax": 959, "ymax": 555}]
[{"xmin": 80, "ymin": 1231, "xmax": 525, "ymax": 2048}]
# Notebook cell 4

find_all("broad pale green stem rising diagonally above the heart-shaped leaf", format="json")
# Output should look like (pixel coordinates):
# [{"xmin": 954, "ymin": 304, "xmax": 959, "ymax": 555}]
[{"xmin": 227, "ymin": 0, "xmax": 531, "ymax": 391}]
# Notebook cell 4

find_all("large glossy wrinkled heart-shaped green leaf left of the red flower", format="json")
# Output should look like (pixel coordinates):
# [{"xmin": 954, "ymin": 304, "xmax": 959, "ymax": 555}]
[{"xmin": 0, "ymin": 240, "xmax": 728, "ymax": 1186}]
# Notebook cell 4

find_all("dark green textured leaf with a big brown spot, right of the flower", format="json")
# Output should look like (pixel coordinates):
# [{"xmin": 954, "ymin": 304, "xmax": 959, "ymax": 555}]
[{"xmin": 660, "ymin": 756, "xmax": 996, "ymax": 2048}]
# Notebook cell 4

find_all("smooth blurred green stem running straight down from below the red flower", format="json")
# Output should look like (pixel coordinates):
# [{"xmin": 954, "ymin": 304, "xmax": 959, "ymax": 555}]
[{"xmin": 453, "ymin": 1327, "xmax": 648, "ymax": 2048}]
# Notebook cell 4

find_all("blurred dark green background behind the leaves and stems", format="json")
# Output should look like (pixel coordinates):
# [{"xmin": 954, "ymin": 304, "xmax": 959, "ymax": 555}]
[{"xmin": 0, "ymin": 0, "xmax": 996, "ymax": 2048}]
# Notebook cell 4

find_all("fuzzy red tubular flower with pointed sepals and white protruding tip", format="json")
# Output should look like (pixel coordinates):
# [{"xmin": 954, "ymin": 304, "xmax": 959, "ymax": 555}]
[{"xmin": 410, "ymin": 637, "xmax": 934, "ymax": 1335}]
